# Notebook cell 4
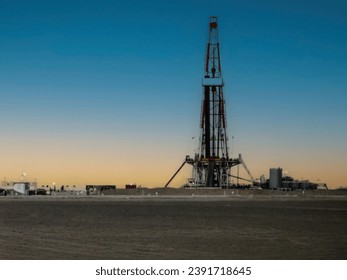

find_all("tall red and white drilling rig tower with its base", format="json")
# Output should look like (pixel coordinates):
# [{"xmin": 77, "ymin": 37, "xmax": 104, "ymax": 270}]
[{"xmin": 165, "ymin": 16, "xmax": 254, "ymax": 188}]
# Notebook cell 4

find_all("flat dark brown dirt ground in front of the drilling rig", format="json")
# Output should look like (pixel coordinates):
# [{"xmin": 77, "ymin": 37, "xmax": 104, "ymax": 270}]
[{"xmin": 0, "ymin": 195, "xmax": 347, "ymax": 260}]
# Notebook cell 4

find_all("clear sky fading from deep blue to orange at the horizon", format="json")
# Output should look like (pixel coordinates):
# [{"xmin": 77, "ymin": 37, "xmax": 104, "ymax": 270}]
[{"xmin": 0, "ymin": 0, "xmax": 347, "ymax": 188}]
